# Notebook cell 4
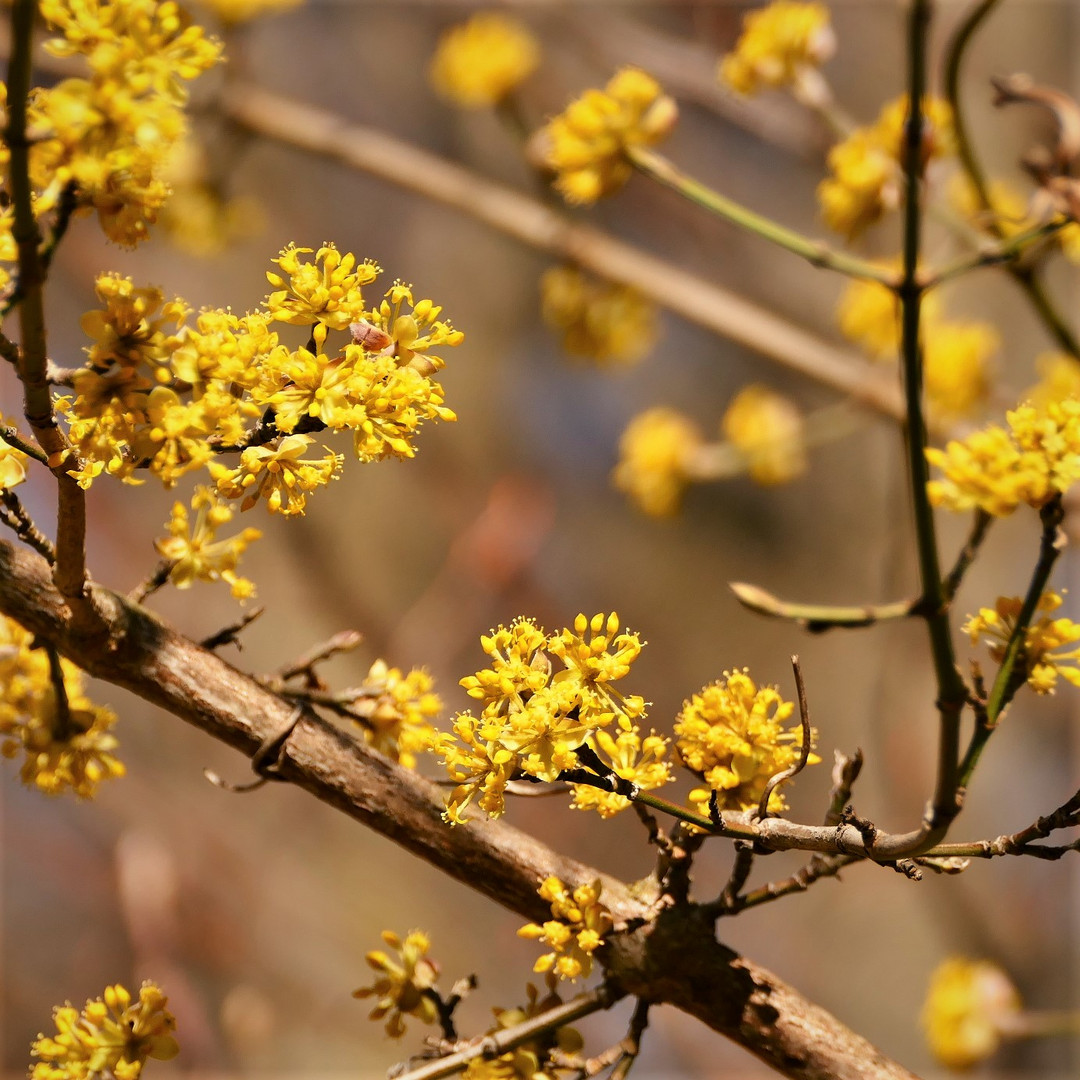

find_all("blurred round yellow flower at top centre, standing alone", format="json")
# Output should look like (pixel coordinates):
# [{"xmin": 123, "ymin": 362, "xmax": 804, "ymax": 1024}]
[{"xmin": 429, "ymin": 12, "xmax": 540, "ymax": 109}]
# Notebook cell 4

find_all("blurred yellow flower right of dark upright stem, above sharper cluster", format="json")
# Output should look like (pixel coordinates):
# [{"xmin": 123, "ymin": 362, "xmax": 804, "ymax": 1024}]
[{"xmin": 922, "ymin": 321, "xmax": 1001, "ymax": 419}]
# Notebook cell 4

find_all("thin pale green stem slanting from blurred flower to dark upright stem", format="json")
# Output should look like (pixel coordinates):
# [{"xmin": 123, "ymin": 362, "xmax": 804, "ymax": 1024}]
[{"xmin": 626, "ymin": 146, "xmax": 896, "ymax": 288}]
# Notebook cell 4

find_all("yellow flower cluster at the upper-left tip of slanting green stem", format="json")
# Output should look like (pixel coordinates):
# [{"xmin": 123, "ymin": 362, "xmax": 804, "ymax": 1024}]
[{"xmin": 539, "ymin": 68, "xmax": 678, "ymax": 203}]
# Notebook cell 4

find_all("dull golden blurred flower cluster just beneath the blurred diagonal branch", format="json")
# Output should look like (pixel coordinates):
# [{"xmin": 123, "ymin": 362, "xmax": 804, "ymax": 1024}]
[{"xmin": 540, "ymin": 266, "xmax": 657, "ymax": 367}]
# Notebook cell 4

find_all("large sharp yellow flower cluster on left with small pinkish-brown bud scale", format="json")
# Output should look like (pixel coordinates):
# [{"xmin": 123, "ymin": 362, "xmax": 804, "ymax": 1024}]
[{"xmin": 58, "ymin": 244, "xmax": 463, "ymax": 514}]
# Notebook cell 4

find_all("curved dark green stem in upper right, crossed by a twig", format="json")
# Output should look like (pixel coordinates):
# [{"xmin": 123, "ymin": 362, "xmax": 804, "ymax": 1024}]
[{"xmin": 944, "ymin": 0, "xmax": 1080, "ymax": 359}]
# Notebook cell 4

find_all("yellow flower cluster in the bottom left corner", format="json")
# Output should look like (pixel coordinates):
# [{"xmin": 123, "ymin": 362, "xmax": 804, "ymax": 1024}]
[{"xmin": 30, "ymin": 983, "xmax": 180, "ymax": 1080}]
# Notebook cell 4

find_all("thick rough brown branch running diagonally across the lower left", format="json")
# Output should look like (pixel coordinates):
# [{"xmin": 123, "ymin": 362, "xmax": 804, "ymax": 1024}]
[{"xmin": 0, "ymin": 541, "xmax": 912, "ymax": 1080}]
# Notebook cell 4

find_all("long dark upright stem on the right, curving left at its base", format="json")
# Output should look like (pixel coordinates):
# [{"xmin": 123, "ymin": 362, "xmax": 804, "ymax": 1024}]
[{"xmin": 891, "ymin": 0, "xmax": 968, "ymax": 858}]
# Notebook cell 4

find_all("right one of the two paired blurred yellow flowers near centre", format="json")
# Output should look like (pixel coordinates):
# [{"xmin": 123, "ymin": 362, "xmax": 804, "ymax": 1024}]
[{"xmin": 720, "ymin": 383, "xmax": 807, "ymax": 486}]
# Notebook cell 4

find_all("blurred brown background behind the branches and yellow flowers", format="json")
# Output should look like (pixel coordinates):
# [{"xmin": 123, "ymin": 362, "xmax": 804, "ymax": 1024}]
[{"xmin": 0, "ymin": 0, "xmax": 1080, "ymax": 1080}]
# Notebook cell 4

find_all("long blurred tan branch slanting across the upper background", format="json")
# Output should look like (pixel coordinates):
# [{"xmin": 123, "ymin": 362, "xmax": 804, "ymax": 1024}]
[{"xmin": 222, "ymin": 85, "xmax": 902, "ymax": 417}]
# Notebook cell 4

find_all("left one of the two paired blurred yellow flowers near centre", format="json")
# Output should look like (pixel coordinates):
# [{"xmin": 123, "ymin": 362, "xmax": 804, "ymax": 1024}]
[{"xmin": 612, "ymin": 407, "xmax": 702, "ymax": 517}]
